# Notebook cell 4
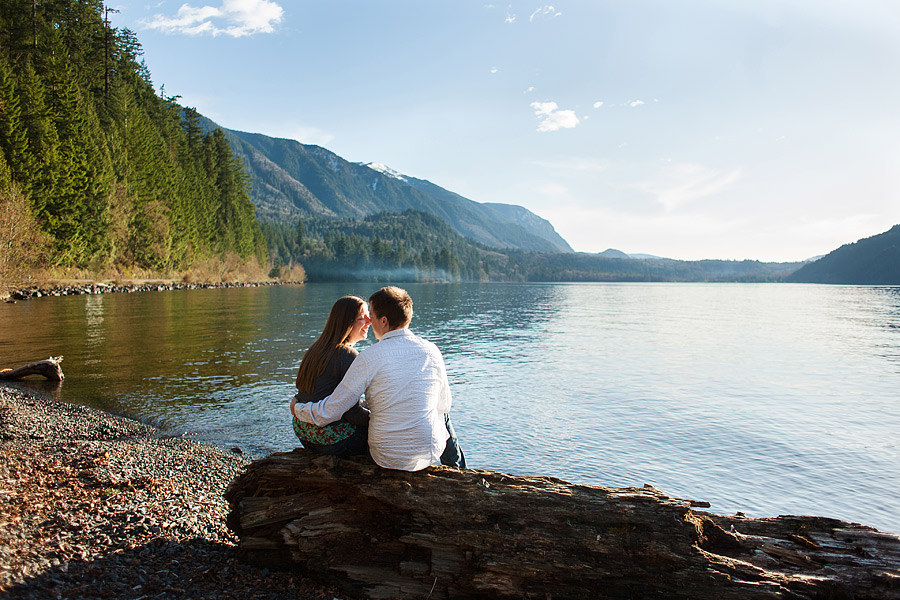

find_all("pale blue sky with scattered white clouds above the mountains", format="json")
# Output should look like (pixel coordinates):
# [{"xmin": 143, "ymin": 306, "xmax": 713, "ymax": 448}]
[{"xmin": 109, "ymin": 0, "xmax": 900, "ymax": 261}]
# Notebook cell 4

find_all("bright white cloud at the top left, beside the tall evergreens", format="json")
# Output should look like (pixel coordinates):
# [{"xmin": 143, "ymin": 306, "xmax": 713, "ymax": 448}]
[{"xmin": 143, "ymin": 0, "xmax": 284, "ymax": 37}]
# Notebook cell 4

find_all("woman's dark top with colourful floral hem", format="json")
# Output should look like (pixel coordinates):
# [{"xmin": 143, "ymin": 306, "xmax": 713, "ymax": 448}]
[{"xmin": 294, "ymin": 346, "xmax": 369, "ymax": 446}]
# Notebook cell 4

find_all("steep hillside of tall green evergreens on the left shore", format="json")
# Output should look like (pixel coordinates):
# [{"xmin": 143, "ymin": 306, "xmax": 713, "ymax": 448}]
[{"xmin": 0, "ymin": 0, "xmax": 266, "ymax": 277}]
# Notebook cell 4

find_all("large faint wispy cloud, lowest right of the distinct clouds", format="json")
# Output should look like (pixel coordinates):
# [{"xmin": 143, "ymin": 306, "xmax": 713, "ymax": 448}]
[{"xmin": 630, "ymin": 163, "xmax": 742, "ymax": 212}]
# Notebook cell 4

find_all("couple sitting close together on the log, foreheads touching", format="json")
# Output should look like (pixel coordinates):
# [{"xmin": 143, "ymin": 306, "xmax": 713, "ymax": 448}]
[{"xmin": 291, "ymin": 286, "xmax": 466, "ymax": 471}]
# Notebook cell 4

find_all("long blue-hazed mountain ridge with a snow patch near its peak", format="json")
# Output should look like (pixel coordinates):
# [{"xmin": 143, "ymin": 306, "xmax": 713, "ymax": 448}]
[{"xmin": 202, "ymin": 119, "xmax": 573, "ymax": 252}]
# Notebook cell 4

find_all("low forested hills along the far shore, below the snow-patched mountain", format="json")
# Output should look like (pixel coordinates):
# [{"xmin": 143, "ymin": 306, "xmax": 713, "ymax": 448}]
[{"xmin": 262, "ymin": 210, "xmax": 799, "ymax": 282}]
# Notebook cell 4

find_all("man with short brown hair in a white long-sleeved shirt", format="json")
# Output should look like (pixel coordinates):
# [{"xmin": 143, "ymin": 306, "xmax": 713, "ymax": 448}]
[{"xmin": 293, "ymin": 286, "xmax": 466, "ymax": 471}]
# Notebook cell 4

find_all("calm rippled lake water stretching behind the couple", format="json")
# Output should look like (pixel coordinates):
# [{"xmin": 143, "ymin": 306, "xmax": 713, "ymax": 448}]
[{"xmin": 0, "ymin": 284, "xmax": 900, "ymax": 533}]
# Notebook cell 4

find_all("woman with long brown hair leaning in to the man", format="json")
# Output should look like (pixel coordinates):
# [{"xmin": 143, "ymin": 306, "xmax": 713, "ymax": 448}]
[{"xmin": 291, "ymin": 296, "xmax": 372, "ymax": 457}]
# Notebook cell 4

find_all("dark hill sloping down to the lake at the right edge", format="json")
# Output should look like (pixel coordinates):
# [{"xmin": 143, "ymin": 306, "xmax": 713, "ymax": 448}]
[{"xmin": 787, "ymin": 225, "xmax": 900, "ymax": 285}]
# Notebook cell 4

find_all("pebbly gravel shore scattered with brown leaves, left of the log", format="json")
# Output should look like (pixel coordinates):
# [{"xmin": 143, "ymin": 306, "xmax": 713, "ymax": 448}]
[{"xmin": 0, "ymin": 387, "xmax": 346, "ymax": 600}]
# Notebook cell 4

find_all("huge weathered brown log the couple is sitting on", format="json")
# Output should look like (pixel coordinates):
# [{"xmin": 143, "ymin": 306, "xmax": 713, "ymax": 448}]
[{"xmin": 225, "ymin": 449, "xmax": 900, "ymax": 600}]
